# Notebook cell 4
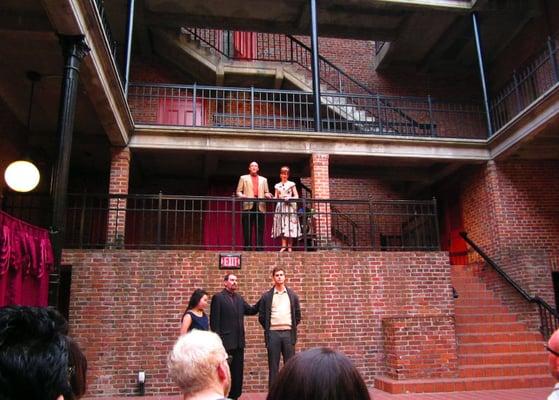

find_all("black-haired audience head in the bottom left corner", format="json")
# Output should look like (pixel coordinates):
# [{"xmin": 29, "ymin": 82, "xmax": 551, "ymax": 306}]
[{"xmin": 0, "ymin": 306, "xmax": 87, "ymax": 400}]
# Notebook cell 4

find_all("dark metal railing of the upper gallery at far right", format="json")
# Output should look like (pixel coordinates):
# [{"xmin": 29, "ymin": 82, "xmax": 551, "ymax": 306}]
[{"xmin": 491, "ymin": 33, "xmax": 559, "ymax": 132}]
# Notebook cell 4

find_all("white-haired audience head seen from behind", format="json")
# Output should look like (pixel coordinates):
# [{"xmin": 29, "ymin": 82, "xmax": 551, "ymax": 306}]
[{"xmin": 167, "ymin": 329, "xmax": 231, "ymax": 399}]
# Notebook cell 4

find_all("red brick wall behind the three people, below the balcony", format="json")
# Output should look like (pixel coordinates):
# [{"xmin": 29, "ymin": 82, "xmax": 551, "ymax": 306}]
[{"xmin": 64, "ymin": 250, "xmax": 454, "ymax": 396}]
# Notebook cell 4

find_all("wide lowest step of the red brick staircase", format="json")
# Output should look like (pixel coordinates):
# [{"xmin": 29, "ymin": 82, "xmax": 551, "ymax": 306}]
[{"xmin": 375, "ymin": 374, "xmax": 554, "ymax": 394}]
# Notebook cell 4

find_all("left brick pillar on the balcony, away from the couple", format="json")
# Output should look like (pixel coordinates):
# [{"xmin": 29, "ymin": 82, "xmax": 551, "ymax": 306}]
[{"xmin": 107, "ymin": 147, "xmax": 130, "ymax": 247}]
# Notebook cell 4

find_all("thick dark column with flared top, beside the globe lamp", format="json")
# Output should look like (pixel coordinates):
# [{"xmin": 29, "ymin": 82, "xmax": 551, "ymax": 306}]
[{"xmin": 49, "ymin": 35, "xmax": 90, "ymax": 306}]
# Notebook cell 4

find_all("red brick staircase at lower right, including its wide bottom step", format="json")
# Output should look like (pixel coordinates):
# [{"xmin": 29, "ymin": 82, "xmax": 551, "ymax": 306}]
[{"xmin": 375, "ymin": 265, "xmax": 555, "ymax": 393}]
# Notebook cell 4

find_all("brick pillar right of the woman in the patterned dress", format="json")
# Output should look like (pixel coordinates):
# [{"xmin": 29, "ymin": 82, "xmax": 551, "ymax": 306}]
[{"xmin": 311, "ymin": 154, "xmax": 331, "ymax": 248}]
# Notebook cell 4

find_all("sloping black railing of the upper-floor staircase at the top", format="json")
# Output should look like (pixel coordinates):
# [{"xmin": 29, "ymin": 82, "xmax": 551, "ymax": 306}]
[{"xmin": 182, "ymin": 27, "xmax": 424, "ymax": 133}]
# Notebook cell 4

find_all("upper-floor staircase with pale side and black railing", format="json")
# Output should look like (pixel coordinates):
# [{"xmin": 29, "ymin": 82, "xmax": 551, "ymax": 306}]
[{"xmin": 154, "ymin": 28, "xmax": 428, "ymax": 136}]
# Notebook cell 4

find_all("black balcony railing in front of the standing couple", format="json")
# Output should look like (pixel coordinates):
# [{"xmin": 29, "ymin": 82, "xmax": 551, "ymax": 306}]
[{"xmin": 3, "ymin": 194, "xmax": 439, "ymax": 251}]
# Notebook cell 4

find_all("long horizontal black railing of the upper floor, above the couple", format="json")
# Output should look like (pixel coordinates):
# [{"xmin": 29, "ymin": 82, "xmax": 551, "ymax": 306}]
[{"xmin": 128, "ymin": 83, "xmax": 486, "ymax": 139}]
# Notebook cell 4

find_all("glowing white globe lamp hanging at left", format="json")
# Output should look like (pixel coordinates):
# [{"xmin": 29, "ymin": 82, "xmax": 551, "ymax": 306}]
[{"xmin": 4, "ymin": 71, "xmax": 41, "ymax": 192}]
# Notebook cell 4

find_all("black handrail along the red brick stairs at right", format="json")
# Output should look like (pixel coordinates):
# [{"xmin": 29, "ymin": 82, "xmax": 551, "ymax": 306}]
[{"xmin": 460, "ymin": 232, "xmax": 559, "ymax": 340}]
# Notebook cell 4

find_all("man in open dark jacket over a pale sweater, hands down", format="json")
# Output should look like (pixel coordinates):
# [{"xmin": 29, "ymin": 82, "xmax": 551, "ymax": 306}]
[{"xmin": 255, "ymin": 267, "xmax": 301, "ymax": 386}]
